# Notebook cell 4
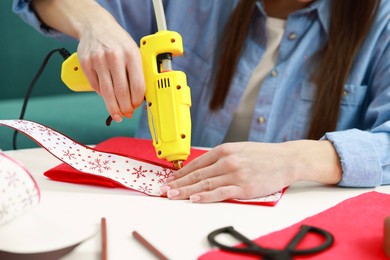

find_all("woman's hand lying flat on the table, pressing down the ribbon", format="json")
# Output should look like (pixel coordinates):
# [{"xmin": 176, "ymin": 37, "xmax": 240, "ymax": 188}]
[{"xmin": 161, "ymin": 141, "xmax": 341, "ymax": 202}]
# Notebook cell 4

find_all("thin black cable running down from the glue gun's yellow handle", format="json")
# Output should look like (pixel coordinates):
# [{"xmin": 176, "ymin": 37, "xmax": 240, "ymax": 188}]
[{"xmin": 12, "ymin": 48, "xmax": 70, "ymax": 150}]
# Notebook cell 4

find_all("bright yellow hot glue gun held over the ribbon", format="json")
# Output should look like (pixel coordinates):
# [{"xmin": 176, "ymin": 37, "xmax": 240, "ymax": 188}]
[{"xmin": 61, "ymin": 30, "xmax": 191, "ymax": 168}]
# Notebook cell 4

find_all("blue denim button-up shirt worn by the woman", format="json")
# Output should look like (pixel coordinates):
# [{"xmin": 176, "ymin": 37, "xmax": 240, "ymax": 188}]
[{"xmin": 13, "ymin": 0, "xmax": 390, "ymax": 187}]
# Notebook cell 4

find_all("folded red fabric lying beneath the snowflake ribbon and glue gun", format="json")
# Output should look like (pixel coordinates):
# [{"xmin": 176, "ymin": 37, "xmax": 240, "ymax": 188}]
[{"xmin": 44, "ymin": 137, "xmax": 206, "ymax": 188}]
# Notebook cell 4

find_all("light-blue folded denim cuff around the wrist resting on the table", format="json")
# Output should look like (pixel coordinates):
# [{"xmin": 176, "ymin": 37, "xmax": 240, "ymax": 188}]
[{"xmin": 322, "ymin": 129, "xmax": 382, "ymax": 187}]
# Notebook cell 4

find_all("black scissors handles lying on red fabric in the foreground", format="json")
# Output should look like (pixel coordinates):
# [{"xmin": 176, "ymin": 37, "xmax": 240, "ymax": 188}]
[{"xmin": 207, "ymin": 225, "xmax": 334, "ymax": 260}]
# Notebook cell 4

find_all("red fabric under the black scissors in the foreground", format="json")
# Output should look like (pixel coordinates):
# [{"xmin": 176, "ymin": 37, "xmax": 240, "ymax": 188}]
[{"xmin": 199, "ymin": 192, "xmax": 390, "ymax": 260}]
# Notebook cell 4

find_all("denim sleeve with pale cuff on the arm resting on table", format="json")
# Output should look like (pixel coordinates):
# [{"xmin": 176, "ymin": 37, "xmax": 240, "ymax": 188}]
[{"xmin": 323, "ymin": 20, "xmax": 390, "ymax": 187}]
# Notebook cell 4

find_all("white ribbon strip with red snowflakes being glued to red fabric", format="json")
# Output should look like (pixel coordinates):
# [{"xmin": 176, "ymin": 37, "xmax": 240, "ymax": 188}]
[{"xmin": 0, "ymin": 120, "xmax": 282, "ymax": 205}]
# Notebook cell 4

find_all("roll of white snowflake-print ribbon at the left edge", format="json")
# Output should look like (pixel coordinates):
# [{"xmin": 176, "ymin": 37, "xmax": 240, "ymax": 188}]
[{"xmin": 0, "ymin": 152, "xmax": 40, "ymax": 225}]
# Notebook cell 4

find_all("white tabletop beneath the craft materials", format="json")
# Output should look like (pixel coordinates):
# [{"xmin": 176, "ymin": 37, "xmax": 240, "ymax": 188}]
[{"xmin": 0, "ymin": 148, "xmax": 390, "ymax": 260}]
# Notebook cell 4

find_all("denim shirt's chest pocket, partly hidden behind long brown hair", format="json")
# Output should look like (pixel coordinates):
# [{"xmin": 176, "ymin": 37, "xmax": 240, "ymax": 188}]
[{"xmin": 294, "ymin": 83, "xmax": 367, "ymax": 139}]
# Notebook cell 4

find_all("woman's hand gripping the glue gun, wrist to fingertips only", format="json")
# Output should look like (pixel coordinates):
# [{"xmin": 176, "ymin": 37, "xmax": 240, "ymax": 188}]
[{"xmin": 77, "ymin": 7, "xmax": 145, "ymax": 122}]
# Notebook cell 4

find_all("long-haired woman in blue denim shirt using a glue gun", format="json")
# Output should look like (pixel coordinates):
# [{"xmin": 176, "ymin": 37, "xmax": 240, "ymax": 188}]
[{"xmin": 14, "ymin": 0, "xmax": 390, "ymax": 202}]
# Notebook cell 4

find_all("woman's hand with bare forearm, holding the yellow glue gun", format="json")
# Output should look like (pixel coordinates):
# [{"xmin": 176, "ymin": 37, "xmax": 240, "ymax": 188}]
[{"xmin": 32, "ymin": 0, "xmax": 145, "ymax": 121}]
